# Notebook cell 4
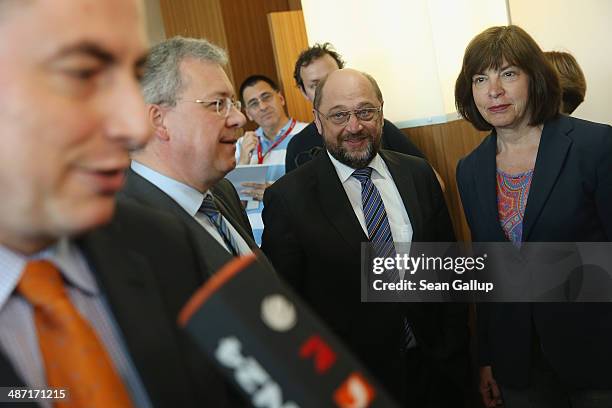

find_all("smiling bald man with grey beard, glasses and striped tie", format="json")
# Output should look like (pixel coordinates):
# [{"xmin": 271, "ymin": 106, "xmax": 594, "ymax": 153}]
[{"xmin": 262, "ymin": 69, "xmax": 469, "ymax": 407}]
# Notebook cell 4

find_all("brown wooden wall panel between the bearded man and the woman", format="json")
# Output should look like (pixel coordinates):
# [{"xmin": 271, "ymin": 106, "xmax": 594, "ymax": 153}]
[{"xmin": 402, "ymin": 120, "xmax": 487, "ymax": 241}]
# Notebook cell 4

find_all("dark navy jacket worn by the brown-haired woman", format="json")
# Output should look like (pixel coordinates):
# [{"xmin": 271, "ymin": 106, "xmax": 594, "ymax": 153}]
[{"xmin": 457, "ymin": 116, "xmax": 612, "ymax": 388}]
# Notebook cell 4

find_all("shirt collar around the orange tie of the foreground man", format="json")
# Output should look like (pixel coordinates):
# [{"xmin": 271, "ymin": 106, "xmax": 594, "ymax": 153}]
[{"xmin": 0, "ymin": 238, "xmax": 100, "ymax": 309}]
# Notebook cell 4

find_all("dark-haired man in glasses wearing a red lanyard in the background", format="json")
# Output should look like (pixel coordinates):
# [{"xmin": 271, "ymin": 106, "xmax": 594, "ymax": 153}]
[{"xmin": 236, "ymin": 75, "xmax": 306, "ymax": 245}]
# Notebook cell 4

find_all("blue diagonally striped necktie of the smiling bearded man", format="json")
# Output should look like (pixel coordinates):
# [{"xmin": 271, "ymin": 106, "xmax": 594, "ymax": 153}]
[{"xmin": 353, "ymin": 167, "xmax": 416, "ymax": 351}]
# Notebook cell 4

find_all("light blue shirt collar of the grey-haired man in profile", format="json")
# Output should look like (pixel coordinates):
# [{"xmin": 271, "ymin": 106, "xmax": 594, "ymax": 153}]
[{"xmin": 131, "ymin": 160, "xmax": 204, "ymax": 217}]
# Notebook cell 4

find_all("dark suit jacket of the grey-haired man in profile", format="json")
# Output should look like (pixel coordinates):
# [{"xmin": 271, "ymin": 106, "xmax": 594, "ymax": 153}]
[{"xmin": 119, "ymin": 169, "xmax": 271, "ymax": 276}]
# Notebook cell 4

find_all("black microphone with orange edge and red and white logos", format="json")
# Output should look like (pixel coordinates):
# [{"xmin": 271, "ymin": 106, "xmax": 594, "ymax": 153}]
[{"xmin": 178, "ymin": 254, "xmax": 398, "ymax": 408}]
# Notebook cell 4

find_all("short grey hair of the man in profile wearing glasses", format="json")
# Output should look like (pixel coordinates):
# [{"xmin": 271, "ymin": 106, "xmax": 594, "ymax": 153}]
[{"xmin": 140, "ymin": 36, "xmax": 227, "ymax": 106}]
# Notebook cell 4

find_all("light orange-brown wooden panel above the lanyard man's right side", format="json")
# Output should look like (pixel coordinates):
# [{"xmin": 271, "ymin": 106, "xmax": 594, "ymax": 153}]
[{"xmin": 268, "ymin": 10, "xmax": 312, "ymax": 123}]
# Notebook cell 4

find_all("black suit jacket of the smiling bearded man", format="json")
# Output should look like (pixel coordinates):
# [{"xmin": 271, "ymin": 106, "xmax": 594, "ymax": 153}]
[{"xmin": 262, "ymin": 151, "xmax": 467, "ymax": 406}]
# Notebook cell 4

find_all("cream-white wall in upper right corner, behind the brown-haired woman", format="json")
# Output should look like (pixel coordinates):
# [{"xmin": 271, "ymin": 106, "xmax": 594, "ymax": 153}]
[{"xmin": 509, "ymin": 0, "xmax": 612, "ymax": 124}]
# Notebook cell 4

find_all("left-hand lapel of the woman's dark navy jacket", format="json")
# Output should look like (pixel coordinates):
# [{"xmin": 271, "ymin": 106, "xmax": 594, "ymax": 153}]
[{"xmin": 474, "ymin": 132, "xmax": 507, "ymax": 242}]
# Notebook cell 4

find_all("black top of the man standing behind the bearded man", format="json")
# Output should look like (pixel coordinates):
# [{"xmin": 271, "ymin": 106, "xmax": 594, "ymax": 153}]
[{"xmin": 285, "ymin": 119, "xmax": 425, "ymax": 173}]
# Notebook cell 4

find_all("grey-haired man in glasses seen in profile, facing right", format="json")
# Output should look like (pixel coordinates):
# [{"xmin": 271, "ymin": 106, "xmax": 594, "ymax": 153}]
[{"xmin": 122, "ymin": 37, "xmax": 265, "ymax": 273}]
